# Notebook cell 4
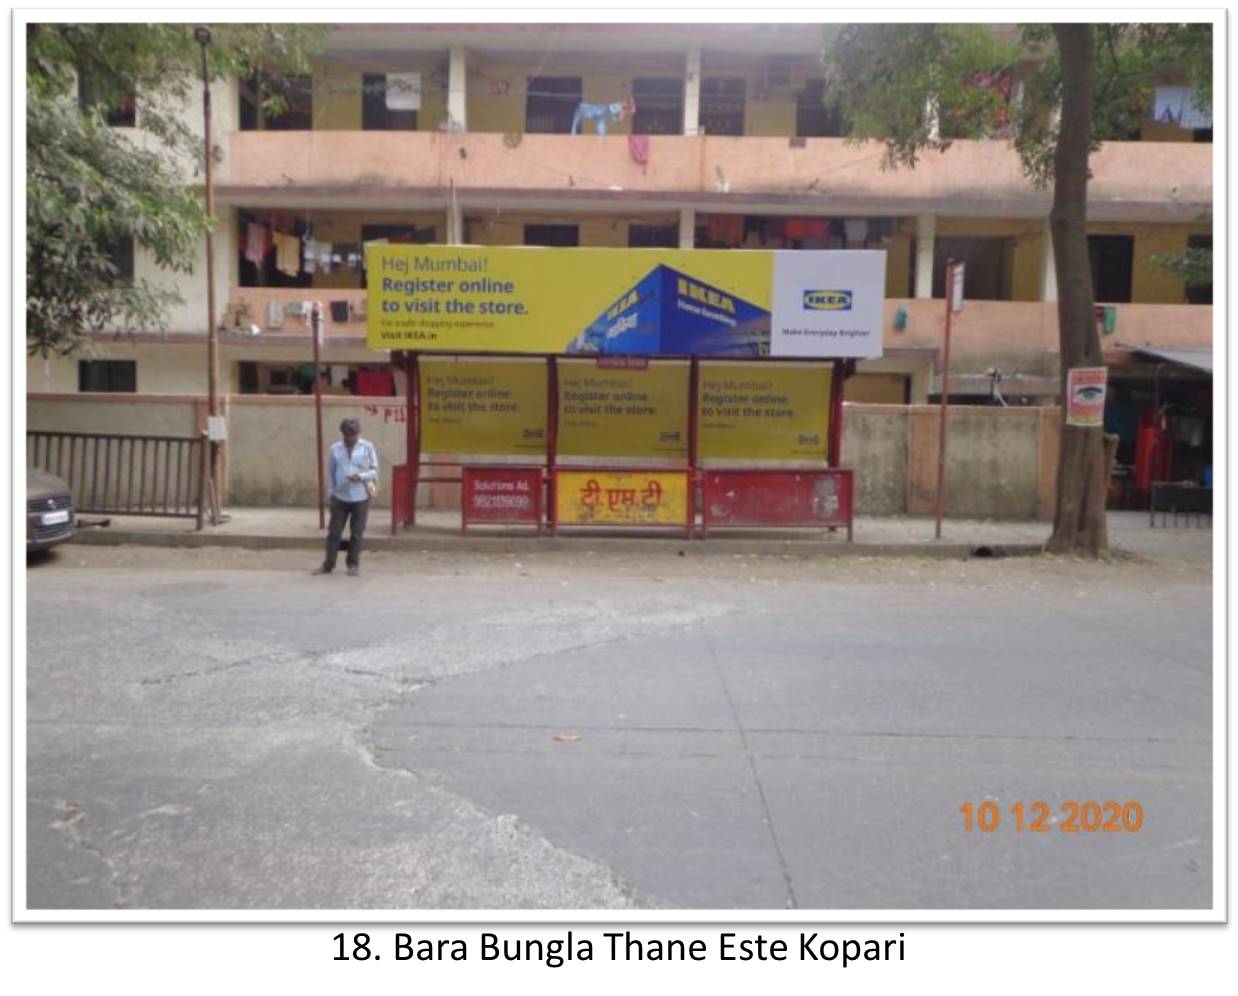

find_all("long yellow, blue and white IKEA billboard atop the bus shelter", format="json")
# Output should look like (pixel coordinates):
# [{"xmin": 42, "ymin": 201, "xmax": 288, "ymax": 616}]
[{"xmin": 365, "ymin": 244, "xmax": 885, "ymax": 359}]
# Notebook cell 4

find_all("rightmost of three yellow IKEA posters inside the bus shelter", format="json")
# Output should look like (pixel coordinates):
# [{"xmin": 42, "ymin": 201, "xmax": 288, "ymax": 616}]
[{"xmin": 697, "ymin": 363, "xmax": 831, "ymax": 460}]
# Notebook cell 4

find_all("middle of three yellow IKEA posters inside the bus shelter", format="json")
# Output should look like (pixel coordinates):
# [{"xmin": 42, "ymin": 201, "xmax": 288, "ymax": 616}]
[{"xmin": 557, "ymin": 360, "xmax": 691, "ymax": 460}]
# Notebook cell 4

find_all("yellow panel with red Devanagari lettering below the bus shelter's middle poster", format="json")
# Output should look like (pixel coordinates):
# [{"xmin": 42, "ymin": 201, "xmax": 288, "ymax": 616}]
[{"xmin": 555, "ymin": 470, "xmax": 688, "ymax": 526}]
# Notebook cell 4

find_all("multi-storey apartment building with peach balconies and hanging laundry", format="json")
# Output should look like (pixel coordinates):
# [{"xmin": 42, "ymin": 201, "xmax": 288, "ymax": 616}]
[{"xmin": 27, "ymin": 24, "xmax": 1212, "ymax": 403}]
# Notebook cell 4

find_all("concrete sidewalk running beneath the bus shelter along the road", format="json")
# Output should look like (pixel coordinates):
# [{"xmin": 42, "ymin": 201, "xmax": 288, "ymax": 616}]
[{"xmin": 65, "ymin": 507, "xmax": 1212, "ymax": 559}]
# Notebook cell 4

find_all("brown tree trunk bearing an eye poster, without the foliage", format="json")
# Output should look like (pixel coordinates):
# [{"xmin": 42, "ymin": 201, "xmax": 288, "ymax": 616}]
[{"xmin": 1047, "ymin": 24, "xmax": 1109, "ymax": 558}]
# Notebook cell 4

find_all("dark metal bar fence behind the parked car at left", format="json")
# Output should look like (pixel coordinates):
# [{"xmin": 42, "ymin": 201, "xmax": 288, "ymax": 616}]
[{"xmin": 26, "ymin": 431, "xmax": 208, "ymax": 530}]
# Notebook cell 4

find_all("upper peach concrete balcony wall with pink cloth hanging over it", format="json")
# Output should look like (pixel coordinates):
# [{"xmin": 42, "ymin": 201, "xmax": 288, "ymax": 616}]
[{"xmin": 219, "ymin": 131, "xmax": 1212, "ymax": 221}]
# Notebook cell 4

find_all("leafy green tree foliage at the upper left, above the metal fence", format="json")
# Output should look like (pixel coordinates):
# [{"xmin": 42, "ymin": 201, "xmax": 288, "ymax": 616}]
[{"xmin": 26, "ymin": 24, "xmax": 326, "ymax": 356}]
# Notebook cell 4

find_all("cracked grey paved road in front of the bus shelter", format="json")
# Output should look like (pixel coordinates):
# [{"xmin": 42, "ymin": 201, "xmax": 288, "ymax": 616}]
[{"xmin": 27, "ymin": 539, "xmax": 1212, "ymax": 909}]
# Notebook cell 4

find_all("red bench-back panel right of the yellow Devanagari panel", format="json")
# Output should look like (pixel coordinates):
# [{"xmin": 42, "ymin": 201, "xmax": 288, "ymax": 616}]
[{"xmin": 702, "ymin": 469, "xmax": 853, "ymax": 539}]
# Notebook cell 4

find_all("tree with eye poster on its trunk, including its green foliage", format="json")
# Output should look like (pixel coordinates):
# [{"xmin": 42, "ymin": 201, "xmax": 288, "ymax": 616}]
[{"xmin": 825, "ymin": 24, "xmax": 1212, "ymax": 557}]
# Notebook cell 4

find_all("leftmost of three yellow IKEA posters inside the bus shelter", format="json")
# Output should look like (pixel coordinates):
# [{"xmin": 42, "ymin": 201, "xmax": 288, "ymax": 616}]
[{"xmin": 418, "ymin": 358, "xmax": 547, "ymax": 455}]
